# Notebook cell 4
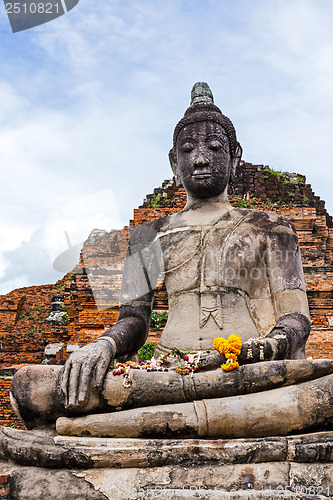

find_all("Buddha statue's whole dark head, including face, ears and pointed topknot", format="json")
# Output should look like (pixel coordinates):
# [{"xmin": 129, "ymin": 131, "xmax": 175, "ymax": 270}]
[{"xmin": 169, "ymin": 82, "xmax": 242, "ymax": 199}]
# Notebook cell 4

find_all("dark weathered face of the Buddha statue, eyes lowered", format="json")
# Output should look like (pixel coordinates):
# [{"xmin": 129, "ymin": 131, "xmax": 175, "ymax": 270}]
[{"xmin": 175, "ymin": 120, "xmax": 233, "ymax": 199}]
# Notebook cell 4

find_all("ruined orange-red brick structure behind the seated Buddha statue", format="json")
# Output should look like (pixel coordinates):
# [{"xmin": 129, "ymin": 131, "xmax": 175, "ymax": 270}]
[{"xmin": 0, "ymin": 162, "xmax": 333, "ymax": 426}]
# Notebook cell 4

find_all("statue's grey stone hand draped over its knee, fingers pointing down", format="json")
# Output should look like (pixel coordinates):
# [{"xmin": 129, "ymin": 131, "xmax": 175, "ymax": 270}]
[{"xmin": 60, "ymin": 340, "xmax": 114, "ymax": 409}]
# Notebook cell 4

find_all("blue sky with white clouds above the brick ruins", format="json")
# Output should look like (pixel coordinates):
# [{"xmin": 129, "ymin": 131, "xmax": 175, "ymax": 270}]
[{"xmin": 0, "ymin": 0, "xmax": 333, "ymax": 294}]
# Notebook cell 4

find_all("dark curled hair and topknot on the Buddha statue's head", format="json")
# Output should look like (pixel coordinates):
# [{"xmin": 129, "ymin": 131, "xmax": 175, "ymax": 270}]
[{"xmin": 169, "ymin": 82, "xmax": 240, "ymax": 164}]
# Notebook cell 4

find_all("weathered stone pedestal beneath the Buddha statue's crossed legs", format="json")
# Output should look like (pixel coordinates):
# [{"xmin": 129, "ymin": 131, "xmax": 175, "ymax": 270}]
[{"xmin": 0, "ymin": 428, "xmax": 333, "ymax": 500}]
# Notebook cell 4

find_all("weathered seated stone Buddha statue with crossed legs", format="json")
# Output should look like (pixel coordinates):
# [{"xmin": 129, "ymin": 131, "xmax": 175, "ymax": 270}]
[{"xmin": 11, "ymin": 83, "xmax": 333, "ymax": 437}]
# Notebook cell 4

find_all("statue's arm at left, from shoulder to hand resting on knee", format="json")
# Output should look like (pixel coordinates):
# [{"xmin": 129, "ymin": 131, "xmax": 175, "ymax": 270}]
[{"xmin": 60, "ymin": 226, "xmax": 162, "ymax": 409}]
